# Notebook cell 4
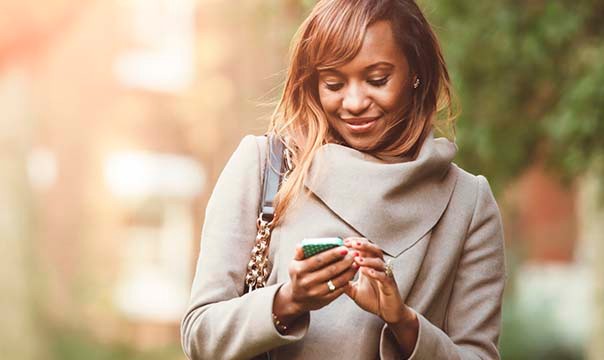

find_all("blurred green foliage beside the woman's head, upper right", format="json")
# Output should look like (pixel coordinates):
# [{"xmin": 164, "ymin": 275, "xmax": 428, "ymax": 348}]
[{"xmin": 420, "ymin": 0, "xmax": 604, "ymax": 189}]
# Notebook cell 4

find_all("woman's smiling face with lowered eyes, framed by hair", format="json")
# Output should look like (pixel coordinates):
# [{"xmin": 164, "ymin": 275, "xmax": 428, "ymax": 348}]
[{"xmin": 319, "ymin": 21, "xmax": 411, "ymax": 150}]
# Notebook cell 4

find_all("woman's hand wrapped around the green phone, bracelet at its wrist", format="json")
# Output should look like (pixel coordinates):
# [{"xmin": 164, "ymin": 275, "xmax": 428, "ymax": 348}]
[{"xmin": 273, "ymin": 245, "xmax": 358, "ymax": 324}]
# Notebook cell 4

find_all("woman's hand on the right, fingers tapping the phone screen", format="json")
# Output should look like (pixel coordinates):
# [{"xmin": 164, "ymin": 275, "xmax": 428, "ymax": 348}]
[{"xmin": 344, "ymin": 238, "xmax": 406, "ymax": 323}]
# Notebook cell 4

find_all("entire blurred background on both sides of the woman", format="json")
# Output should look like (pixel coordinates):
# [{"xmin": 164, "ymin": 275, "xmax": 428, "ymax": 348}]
[{"xmin": 0, "ymin": 0, "xmax": 604, "ymax": 360}]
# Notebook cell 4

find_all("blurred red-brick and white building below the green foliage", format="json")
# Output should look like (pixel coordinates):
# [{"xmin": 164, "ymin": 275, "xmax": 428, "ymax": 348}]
[{"xmin": 500, "ymin": 162, "xmax": 599, "ymax": 359}]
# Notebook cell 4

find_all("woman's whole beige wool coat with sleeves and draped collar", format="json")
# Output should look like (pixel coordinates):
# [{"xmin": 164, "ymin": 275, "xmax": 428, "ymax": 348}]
[{"xmin": 181, "ymin": 135, "xmax": 505, "ymax": 360}]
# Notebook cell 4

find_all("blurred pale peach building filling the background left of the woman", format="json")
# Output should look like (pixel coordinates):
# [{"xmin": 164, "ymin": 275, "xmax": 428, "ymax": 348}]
[{"xmin": 0, "ymin": 0, "xmax": 306, "ymax": 359}]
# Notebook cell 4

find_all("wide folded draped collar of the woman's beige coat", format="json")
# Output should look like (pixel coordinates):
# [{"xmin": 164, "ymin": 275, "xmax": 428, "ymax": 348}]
[{"xmin": 304, "ymin": 133, "xmax": 457, "ymax": 256}]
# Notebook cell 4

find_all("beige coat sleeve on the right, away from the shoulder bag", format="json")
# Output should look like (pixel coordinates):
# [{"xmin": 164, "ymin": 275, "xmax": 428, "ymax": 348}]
[{"xmin": 380, "ymin": 176, "xmax": 506, "ymax": 360}]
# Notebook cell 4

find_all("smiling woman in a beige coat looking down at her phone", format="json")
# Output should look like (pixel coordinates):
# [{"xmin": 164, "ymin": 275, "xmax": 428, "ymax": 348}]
[{"xmin": 182, "ymin": 0, "xmax": 505, "ymax": 359}]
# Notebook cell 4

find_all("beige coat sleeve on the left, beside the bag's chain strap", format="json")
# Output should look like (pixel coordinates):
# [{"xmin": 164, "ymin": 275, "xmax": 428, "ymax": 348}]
[{"xmin": 181, "ymin": 135, "xmax": 308, "ymax": 360}]
